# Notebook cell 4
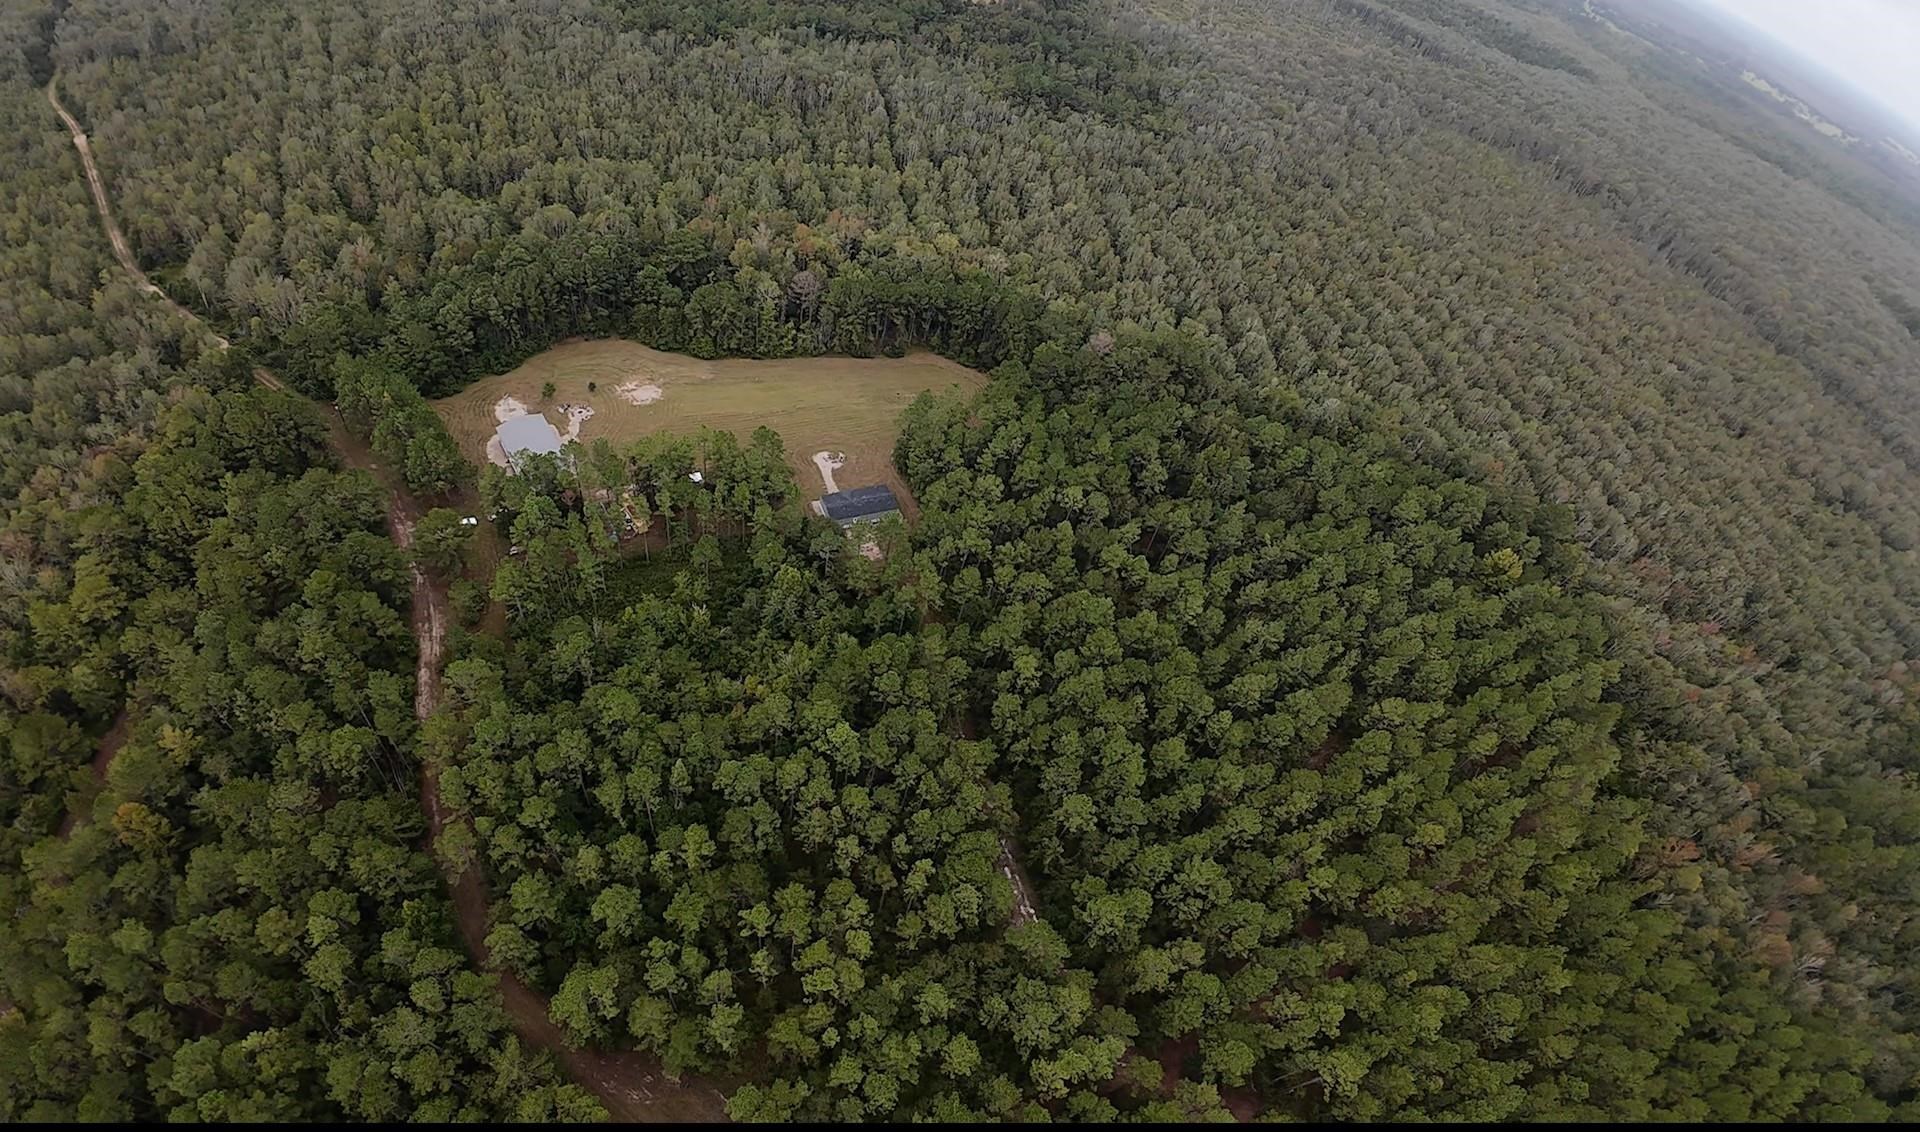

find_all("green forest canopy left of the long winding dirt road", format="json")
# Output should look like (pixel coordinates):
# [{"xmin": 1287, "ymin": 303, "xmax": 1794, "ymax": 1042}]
[{"xmin": 0, "ymin": 10, "xmax": 599, "ymax": 1120}]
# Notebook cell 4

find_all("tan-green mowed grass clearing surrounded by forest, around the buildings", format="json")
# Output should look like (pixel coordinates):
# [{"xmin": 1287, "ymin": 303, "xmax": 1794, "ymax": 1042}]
[{"xmin": 434, "ymin": 338, "xmax": 987, "ymax": 507}]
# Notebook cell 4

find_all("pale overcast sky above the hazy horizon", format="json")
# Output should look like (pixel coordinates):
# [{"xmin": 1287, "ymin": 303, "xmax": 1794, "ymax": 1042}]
[{"xmin": 1697, "ymin": 0, "xmax": 1920, "ymax": 129}]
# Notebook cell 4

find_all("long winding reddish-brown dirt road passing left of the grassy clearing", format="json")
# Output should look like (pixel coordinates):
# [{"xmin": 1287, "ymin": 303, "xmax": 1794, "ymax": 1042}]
[{"xmin": 46, "ymin": 77, "xmax": 726, "ymax": 1122}]
